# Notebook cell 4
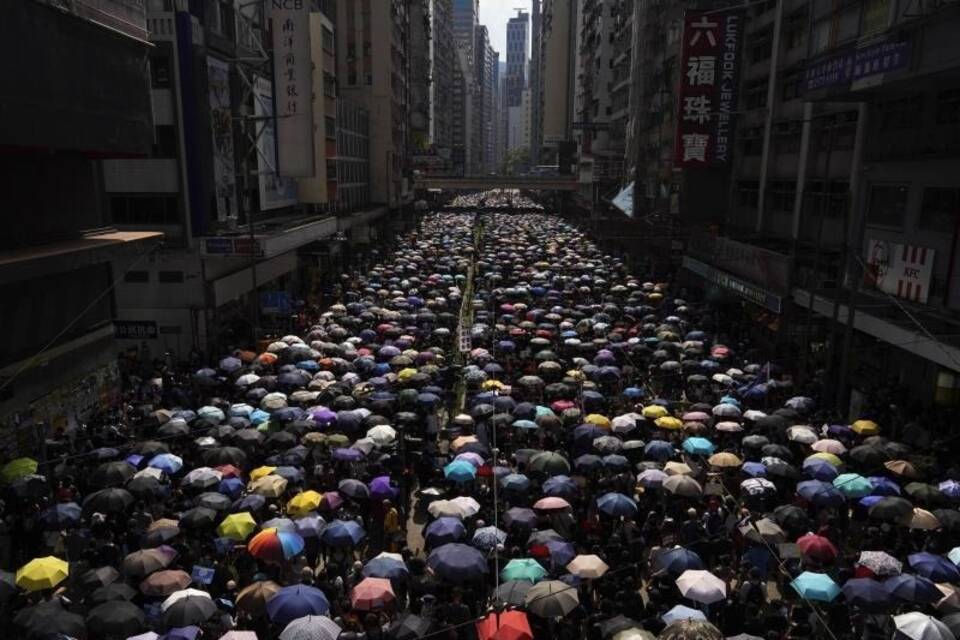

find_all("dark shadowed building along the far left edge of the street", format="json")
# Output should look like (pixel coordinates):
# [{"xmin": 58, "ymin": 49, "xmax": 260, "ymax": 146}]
[{"xmin": 0, "ymin": 0, "xmax": 161, "ymax": 458}]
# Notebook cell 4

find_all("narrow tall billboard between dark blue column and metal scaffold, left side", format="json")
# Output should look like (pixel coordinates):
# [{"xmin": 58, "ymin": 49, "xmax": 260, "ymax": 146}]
[{"xmin": 207, "ymin": 56, "xmax": 237, "ymax": 222}]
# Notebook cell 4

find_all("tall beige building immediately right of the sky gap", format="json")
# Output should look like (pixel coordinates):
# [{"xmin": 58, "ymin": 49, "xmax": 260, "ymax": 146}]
[{"xmin": 539, "ymin": 0, "xmax": 579, "ymax": 165}]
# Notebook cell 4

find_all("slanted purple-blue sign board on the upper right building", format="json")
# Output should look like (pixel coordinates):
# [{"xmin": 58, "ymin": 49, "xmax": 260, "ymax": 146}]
[{"xmin": 803, "ymin": 41, "xmax": 910, "ymax": 91}]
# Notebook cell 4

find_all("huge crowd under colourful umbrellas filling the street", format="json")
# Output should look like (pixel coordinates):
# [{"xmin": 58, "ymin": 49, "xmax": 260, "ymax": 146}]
[{"xmin": 0, "ymin": 201, "xmax": 960, "ymax": 640}]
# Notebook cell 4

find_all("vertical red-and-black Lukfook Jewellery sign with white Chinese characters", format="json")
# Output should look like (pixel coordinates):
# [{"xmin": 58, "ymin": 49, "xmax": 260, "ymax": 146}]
[{"xmin": 674, "ymin": 11, "xmax": 744, "ymax": 168}]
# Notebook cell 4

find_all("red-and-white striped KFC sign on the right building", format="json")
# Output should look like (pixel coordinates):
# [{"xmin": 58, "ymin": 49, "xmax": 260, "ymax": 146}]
[{"xmin": 864, "ymin": 238, "xmax": 934, "ymax": 304}]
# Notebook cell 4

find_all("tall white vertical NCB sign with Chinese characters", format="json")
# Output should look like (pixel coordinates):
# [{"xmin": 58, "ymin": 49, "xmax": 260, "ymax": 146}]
[{"xmin": 269, "ymin": 0, "xmax": 313, "ymax": 178}]
